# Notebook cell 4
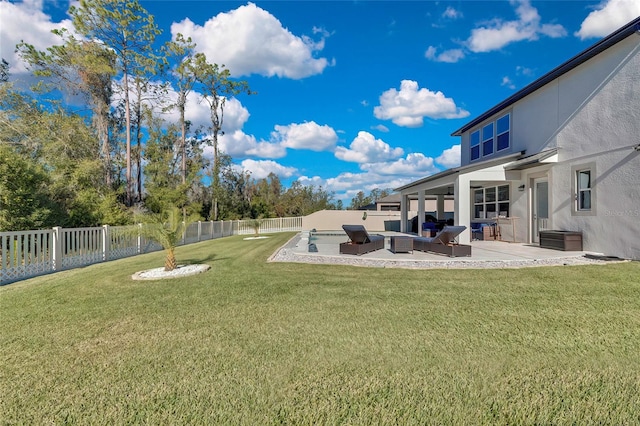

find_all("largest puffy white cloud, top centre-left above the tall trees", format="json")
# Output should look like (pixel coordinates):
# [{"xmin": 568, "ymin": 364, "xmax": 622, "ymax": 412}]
[{"xmin": 171, "ymin": 3, "xmax": 330, "ymax": 79}]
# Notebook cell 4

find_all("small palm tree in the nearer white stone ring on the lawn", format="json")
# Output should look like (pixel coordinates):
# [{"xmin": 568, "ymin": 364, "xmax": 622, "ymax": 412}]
[{"xmin": 140, "ymin": 207, "xmax": 192, "ymax": 271}]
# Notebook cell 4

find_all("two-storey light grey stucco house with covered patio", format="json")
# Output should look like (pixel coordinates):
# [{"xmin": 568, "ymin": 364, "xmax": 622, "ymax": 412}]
[{"xmin": 396, "ymin": 17, "xmax": 640, "ymax": 259}]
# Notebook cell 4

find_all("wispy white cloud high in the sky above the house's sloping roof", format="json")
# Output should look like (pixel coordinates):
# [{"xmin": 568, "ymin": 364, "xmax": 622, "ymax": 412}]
[{"xmin": 467, "ymin": 0, "xmax": 566, "ymax": 53}]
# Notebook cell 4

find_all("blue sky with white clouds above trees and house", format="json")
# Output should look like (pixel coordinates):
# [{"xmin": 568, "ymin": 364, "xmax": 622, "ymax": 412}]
[{"xmin": 0, "ymin": 0, "xmax": 640, "ymax": 204}]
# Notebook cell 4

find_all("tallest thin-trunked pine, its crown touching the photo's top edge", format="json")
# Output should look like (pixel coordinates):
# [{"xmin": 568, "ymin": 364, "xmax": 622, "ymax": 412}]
[{"xmin": 69, "ymin": 0, "xmax": 160, "ymax": 205}]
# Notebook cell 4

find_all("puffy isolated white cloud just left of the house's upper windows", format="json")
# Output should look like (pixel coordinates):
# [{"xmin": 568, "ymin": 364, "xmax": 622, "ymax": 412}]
[{"xmin": 373, "ymin": 80, "xmax": 469, "ymax": 127}]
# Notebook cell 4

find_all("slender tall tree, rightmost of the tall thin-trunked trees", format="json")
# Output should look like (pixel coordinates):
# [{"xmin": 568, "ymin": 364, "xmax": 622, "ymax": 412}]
[{"xmin": 193, "ymin": 53, "xmax": 252, "ymax": 220}]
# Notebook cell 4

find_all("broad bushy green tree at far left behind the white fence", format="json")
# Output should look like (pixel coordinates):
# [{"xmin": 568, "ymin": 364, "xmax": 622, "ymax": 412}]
[{"xmin": 0, "ymin": 84, "xmax": 127, "ymax": 227}]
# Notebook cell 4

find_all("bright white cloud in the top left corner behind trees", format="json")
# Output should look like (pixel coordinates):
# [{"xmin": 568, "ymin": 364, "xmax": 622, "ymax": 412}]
[{"xmin": 0, "ymin": 0, "xmax": 72, "ymax": 74}]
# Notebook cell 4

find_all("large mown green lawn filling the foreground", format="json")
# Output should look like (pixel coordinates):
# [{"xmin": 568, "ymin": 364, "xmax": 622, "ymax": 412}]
[{"xmin": 0, "ymin": 234, "xmax": 640, "ymax": 425}]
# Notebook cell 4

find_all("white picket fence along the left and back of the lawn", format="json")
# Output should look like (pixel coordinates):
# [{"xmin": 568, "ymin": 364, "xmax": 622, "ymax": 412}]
[{"xmin": 0, "ymin": 217, "xmax": 302, "ymax": 285}]
